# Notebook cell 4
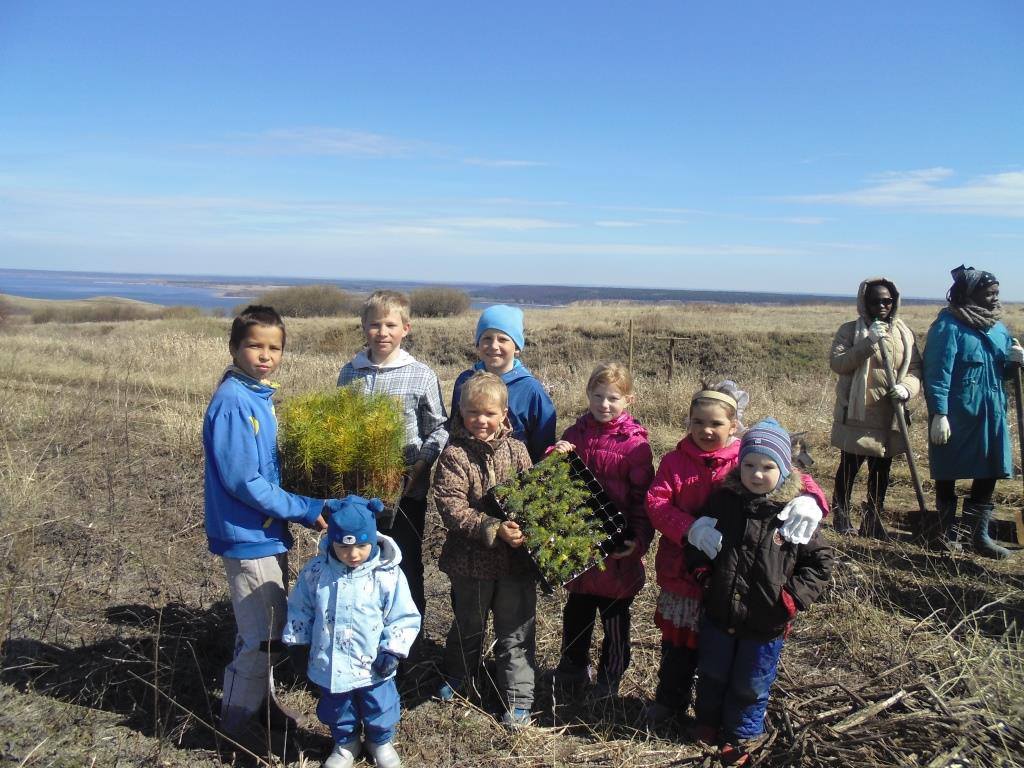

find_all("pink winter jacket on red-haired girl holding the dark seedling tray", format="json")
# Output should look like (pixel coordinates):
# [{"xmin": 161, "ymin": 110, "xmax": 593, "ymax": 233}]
[{"xmin": 562, "ymin": 411, "xmax": 654, "ymax": 599}]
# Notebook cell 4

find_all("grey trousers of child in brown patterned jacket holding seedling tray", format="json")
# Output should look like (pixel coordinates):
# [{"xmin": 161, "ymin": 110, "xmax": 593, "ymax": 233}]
[{"xmin": 444, "ymin": 577, "xmax": 537, "ymax": 710}]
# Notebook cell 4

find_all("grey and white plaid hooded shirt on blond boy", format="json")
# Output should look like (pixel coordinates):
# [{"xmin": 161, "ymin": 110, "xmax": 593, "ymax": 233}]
[{"xmin": 338, "ymin": 350, "xmax": 447, "ymax": 499}]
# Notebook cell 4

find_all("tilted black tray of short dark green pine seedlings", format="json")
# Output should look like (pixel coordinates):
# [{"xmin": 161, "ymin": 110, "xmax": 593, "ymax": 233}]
[{"xmin": 490, "ymin": 452, "xmax": 628, "ymax": 595}]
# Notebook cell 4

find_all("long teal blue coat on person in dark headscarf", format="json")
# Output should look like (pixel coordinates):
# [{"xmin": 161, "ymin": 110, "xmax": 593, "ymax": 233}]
[{"xmin": 925, "ymin": 309, "xmax": 1013, "ymax": 480}]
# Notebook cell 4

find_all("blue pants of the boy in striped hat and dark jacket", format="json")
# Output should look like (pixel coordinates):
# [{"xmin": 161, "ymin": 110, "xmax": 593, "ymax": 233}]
[{"xmin": 694, "ymin": 618, "xmax": 782, "ymax": 741}]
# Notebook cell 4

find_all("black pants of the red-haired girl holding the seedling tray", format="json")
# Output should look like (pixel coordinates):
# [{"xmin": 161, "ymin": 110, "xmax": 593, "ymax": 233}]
[{"xmin": 562, "ymin": 592, "xmax": 633, "ymax": 682}]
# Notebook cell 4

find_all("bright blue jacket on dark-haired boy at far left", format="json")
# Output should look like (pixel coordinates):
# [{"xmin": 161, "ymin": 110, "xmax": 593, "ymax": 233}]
[{"xmin": 203, "ymin": 369, "xmax": 324, "ymax": 560}]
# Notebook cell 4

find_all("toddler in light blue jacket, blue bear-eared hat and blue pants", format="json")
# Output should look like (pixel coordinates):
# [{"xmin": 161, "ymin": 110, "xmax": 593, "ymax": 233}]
[{"xmin": 282, "ymin": 496, "xmax": 421, "ymax": 768}]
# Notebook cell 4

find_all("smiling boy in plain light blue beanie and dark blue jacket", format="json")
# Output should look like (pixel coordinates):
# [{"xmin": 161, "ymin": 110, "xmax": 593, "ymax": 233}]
[{"xmin": 452, "ymin": 304, "xmax": 556, "ymax": 462}]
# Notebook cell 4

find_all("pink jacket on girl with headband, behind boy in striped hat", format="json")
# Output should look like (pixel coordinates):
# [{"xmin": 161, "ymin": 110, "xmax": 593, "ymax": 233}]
[{"xmin": 647, "ymin": 435, "xmax": 828, "ymax": 600}]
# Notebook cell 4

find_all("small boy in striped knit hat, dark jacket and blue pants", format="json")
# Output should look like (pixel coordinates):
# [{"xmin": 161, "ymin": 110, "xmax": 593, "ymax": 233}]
[{"xmin": 685, "ymin": 419, "xmax": 833, "ymax": 765}]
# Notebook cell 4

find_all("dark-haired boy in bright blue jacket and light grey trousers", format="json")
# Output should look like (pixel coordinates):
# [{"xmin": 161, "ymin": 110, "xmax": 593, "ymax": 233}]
[{"xmin": 203, "ymin": 305, "xmax": 327, "ymax": 744}]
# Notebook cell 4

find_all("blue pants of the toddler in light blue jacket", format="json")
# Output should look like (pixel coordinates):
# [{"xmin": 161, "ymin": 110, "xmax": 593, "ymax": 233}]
[{"xmin": 316, "ymin": 677, "xmax": 401, "ymax": 744}]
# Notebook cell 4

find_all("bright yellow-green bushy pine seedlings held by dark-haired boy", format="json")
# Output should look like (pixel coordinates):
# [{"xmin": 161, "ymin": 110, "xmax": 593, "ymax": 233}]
[{"xmin": 278, "ymin": 386, "xmax": 406, "ymax": 527}]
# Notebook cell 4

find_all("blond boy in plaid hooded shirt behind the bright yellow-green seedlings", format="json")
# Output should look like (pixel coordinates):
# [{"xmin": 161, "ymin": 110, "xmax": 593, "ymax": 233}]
[{"xmin": 338, "ymin": 291, "xmax": 447, "ymax": 615}]
